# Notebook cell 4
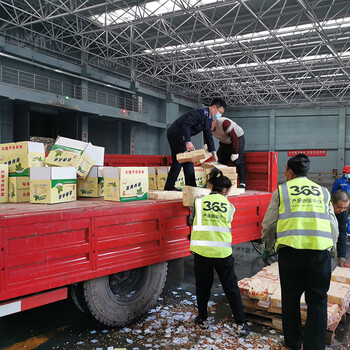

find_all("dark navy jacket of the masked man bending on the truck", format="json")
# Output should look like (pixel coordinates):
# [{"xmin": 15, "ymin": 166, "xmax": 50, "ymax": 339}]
[{"xmin": 168, "ymin": 108, "xmax": 215, "ymax": 152}]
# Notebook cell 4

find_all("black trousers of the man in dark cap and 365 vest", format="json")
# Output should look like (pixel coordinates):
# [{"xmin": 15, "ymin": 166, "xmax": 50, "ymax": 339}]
[{"xmin": 278, "ymin": 247, "xmax": 331, "ymax": 350}]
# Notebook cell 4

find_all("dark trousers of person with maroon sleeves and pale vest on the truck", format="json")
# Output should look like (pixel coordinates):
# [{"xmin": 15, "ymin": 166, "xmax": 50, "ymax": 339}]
[{"xmin": 217, "ymin": 135, "xmax": 246, "ymax": 184}]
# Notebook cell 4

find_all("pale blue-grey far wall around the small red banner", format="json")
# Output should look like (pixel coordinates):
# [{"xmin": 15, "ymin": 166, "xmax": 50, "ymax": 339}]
[{"xmin": 231, "ymin": 107, "xmax": 350, "ymax": 172}]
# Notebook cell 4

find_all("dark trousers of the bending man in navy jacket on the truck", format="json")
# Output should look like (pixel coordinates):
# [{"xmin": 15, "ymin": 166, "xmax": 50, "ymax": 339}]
[{"xmin": 164, "ymin": 132, "xmax": 196, "ymax": 191}]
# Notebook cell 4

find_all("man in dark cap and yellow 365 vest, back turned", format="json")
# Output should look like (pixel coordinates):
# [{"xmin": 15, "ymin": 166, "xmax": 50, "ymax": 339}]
[{"xmin": 262, "ymin": 153, "xmax": 337, "ymax": 350}]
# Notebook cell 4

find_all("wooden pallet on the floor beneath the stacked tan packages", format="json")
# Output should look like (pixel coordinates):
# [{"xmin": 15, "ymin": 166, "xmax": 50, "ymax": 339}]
[{"xmin": 242, "ymin": 300, "xmax": 346, "ymax": 345}]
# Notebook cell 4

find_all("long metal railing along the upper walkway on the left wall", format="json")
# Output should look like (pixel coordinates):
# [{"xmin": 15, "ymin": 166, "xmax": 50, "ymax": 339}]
[{"xmin": 0, "ymin": 66, "xmax": 148, "ymax": 115}]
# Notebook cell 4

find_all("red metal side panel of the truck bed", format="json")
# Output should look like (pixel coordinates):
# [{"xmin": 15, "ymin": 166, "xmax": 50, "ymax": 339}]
[{"xmin": 0, "ymin": 191, "xmax": 271, "ymax": 301}]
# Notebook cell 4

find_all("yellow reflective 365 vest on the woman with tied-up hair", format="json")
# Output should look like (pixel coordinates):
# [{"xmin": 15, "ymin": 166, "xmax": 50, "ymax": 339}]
[{"xmin": 190, "ymin": 194, "xmax": 236, "ymax": 258}]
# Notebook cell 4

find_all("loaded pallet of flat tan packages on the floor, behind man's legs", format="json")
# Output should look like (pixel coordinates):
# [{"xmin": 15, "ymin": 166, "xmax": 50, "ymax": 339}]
[{"xmin": 238, "ymin": 262, "xmax": 350, "ymax": 338}]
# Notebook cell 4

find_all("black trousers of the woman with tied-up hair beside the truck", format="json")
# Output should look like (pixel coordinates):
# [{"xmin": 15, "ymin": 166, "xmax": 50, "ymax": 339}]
[{"xmin": 194, "ymin": 254, "xmax": 245, "ymax": 324}]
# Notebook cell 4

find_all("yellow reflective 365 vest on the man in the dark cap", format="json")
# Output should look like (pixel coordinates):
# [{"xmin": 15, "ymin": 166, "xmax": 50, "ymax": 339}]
[{"xmin": 275, "ymin": 177, "xmax": 333, "ymax": 250}]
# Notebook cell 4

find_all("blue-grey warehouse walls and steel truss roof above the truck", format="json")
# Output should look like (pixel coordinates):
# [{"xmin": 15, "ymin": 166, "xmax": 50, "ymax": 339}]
[{"xmin": 0, "ymin": 0, "xmax": 350, "ymax": 172}]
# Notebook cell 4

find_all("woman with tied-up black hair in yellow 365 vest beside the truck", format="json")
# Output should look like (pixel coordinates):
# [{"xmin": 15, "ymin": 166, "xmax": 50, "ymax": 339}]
[{"xmin": 190, "ymin": 168, "xmax": 250, "ymax": 336}]
